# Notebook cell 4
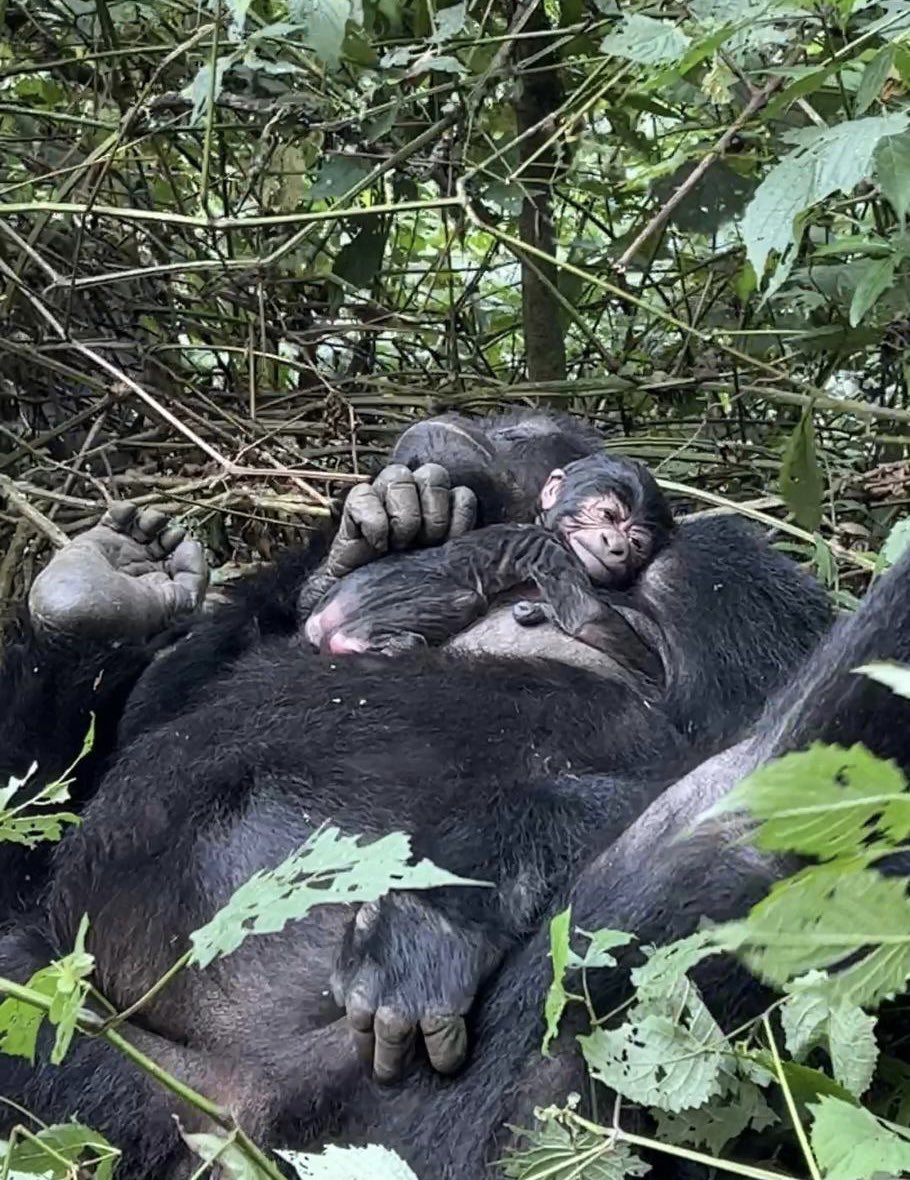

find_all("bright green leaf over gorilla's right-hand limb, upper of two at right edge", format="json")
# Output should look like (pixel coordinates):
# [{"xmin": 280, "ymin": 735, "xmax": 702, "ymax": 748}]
[{"xmin": 703, "ymin": 742, "xmax": 910, "ymax": 860}]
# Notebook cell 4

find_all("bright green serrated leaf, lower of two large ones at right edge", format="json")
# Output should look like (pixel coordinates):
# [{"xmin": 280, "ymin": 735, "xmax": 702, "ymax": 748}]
[{"xmin": 714, "ymin": 859, "xmax": 910, "ymax": 1008}]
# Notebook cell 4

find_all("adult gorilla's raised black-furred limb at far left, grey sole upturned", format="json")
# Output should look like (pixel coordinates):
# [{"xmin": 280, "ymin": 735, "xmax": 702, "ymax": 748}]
[{"xmin": 0, "ymin": 504, "xmax": 207, "ymax": 782}]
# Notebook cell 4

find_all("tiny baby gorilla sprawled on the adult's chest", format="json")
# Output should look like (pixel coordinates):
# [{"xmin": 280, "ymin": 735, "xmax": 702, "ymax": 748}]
[{"xmin": 305, "ymin": 453, "xmax": 673, "ymax": 680}]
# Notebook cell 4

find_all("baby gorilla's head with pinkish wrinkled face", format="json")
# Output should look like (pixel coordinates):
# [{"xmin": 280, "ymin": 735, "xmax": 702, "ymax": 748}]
[{"xmin": 537, "ymin": 453, "xmax": 673, "ymax": 589}]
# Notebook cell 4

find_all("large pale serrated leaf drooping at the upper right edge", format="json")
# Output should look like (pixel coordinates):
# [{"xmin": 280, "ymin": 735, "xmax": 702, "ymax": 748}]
[{"xmin": 742, "ymin": 113, "xmax": 910, "ymax": 283}]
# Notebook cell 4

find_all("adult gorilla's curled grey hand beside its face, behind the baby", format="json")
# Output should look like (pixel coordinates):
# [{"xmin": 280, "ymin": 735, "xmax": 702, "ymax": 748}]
[{"xmin": 328, "ymin": 463, "xmax": 477, "ymax": 578}]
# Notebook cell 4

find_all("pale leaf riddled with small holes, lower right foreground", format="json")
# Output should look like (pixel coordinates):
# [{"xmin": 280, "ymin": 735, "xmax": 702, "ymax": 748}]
[{"xmin": 578, "ymin": 1014, "xmax": 728, "ymax": 1112}]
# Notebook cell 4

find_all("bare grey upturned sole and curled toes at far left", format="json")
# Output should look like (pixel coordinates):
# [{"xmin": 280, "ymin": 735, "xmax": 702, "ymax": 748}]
[{"xmin": 28, "ymin": 504, "xmax": 208, "ymax": 640}]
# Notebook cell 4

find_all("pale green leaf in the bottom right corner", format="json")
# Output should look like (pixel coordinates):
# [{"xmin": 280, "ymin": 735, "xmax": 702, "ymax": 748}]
[{"xmin": 810, "ymin": 1097, "xmax": 910, "ymax": 1180}]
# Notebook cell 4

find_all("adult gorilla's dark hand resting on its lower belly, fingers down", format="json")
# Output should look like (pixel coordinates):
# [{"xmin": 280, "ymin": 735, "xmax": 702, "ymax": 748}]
[{"xmin": 332, "ymin": 893, "xmax": 504, "ymax": 1082}]
